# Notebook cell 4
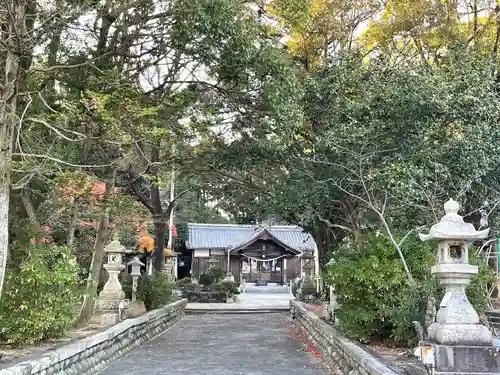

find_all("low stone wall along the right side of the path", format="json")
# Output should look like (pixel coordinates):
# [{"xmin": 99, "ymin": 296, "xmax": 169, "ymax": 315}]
[{"xmin": 290, "ymin": 301, "xmax": 397, "ymax": 375}]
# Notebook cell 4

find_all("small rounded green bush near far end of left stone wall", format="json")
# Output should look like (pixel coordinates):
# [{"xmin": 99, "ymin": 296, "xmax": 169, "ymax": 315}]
[{"xmin": 137, "ymin": 272, "xmax": 175, "ymax": 310}]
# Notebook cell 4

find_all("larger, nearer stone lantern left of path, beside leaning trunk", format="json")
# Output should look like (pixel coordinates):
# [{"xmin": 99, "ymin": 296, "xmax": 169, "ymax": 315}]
[{"xmin": 94, "ymin": 239, "xmax": 128, "ymax": 325}]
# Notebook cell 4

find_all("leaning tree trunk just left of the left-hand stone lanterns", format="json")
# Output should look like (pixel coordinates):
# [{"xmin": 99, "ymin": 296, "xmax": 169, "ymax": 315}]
[{"xmin": 76, "ymin": 176, "xmax": 114, "ymax": 327}]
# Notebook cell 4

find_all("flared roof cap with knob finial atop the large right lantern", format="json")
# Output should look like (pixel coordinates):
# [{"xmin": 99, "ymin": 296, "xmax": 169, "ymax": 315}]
[{"xmin": 419, "ymin": 198, "xmax": 490, "ymax": 241}]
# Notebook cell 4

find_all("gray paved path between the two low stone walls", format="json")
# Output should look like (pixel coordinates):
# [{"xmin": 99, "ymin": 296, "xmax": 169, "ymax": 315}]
[{"xmin": 101, "ymin": 314, "xmax": 328, "ymax": 375}]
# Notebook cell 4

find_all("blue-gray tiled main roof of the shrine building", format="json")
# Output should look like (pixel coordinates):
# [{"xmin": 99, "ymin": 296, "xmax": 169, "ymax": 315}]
[{"xmin": 186, "ymin": 223, "xmax": 316, "ymax": 251}]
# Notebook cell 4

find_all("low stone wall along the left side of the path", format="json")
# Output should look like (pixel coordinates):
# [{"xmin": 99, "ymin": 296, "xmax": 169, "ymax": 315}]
[{"xmin": 0, "ymin": 300, "xmax": 187, "ymax": 375}]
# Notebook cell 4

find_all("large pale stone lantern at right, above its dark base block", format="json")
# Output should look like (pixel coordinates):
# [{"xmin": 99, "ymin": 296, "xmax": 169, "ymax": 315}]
[{"xmin": 420, "ymin": 199, "xmax": 492, "ymax": 346}]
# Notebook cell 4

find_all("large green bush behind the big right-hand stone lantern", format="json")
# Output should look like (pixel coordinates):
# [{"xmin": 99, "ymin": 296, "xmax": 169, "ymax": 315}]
[{"xmin": 327, "ymin": 233, "xmax": 492, "ymax": 344}]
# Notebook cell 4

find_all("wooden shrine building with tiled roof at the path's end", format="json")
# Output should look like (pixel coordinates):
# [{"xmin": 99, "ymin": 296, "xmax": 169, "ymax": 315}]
[{"xmin": 186, "ymin": 223, "xmax": 318, "ymax": 285}]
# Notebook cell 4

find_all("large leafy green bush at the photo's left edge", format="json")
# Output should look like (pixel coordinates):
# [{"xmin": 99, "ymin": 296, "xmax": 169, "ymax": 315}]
[{"xmin": 0, "ymin": 245, "xmax": 80, "ymax": 346}]
